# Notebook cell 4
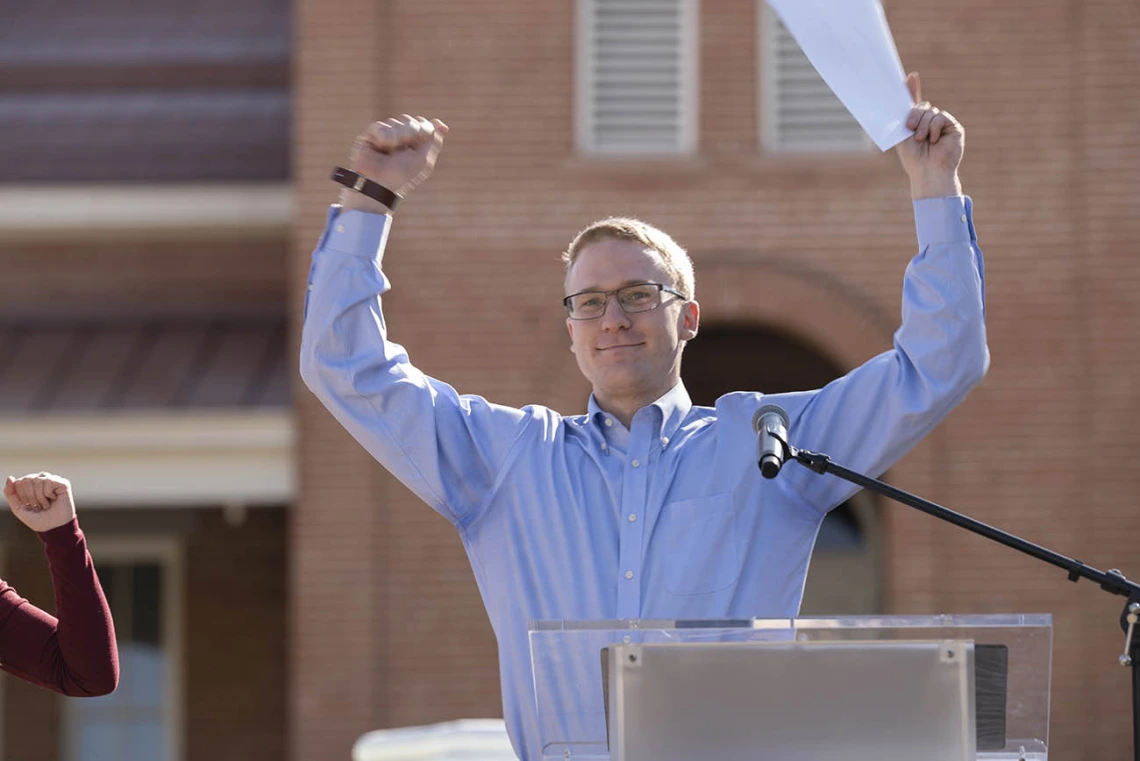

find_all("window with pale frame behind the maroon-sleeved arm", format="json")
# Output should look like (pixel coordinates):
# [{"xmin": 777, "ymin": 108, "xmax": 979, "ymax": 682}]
[{"xmin": 63, "ymin": 540, "xmax": 181, "ymax": 761}]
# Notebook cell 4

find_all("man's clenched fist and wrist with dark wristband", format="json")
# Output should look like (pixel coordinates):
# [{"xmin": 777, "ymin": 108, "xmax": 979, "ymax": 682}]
[{"xmin": 341, "ymin": 114, "xmax": 448, "ymax": 214}]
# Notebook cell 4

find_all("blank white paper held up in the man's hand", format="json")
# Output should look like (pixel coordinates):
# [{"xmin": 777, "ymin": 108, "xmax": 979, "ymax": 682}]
[{"xmin": 768, "ymin": 0, "xmax": 914, "ymax": 150}]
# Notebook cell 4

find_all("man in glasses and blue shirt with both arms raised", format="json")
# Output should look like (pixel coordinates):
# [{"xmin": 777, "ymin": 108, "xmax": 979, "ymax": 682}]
[{"xmin": 301, "ymin": 74, "xmax": 988, "ymax": 759}]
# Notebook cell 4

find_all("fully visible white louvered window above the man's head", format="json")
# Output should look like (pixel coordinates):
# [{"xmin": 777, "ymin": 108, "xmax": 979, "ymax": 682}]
[{"xmin": 577, "ymin": 0, "xmax": 698, "ymax": 156}]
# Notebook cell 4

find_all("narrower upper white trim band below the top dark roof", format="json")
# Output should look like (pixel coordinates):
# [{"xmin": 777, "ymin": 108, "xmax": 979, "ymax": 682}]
[{"xmin": 0, "ymin": 182, "xmax": 293, "ymax": 240}]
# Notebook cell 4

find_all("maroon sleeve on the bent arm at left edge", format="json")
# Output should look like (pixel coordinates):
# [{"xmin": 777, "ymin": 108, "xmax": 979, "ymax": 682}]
[{"xmin": 0, "ymin": 519, "xmax": 119, "ymax": 697}]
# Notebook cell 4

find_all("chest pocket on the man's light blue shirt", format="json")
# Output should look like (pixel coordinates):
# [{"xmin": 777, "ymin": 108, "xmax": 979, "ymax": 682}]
[{"xmin": 659, "ymin": 493, "xmax": 741, "ymax": 595}]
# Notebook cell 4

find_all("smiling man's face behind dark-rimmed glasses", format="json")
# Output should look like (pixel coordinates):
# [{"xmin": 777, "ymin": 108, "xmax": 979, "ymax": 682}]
[{"xmin": 567, "ymin": 239, "xmax": 699, "ymax": 403}]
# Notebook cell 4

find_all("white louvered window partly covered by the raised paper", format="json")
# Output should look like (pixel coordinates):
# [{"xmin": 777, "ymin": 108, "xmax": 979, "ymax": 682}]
[{"xmin": 759, "ymin": 0, "xmax": 874, "ymax": 153}]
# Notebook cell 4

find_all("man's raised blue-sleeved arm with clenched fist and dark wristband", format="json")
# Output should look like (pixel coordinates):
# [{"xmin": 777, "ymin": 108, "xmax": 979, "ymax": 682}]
[{"xmin": 301, "ymin": 115, "xmax": 529, "ymax": 526}]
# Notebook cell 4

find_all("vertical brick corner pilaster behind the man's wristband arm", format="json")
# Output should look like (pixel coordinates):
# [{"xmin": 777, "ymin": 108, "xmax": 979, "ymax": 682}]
[{"xmin": 287, "ymin": 0, "xmax": 398, "ymax": 759}]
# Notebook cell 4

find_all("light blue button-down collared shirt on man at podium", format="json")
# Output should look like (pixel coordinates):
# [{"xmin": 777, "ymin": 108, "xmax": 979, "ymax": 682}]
[{"xmin": 301, "ymin": 196, "xmax": 990, "ymax": 760}]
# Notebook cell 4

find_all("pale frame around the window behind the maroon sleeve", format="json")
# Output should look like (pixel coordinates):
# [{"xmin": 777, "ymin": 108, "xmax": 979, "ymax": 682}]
[{"xmin": 60, "ymin": 531, "xmax": 186, "ymax": 761}]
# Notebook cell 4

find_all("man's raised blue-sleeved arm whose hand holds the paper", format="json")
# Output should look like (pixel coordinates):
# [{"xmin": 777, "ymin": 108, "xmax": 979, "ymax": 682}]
[{"xmin": 752, "ymin": 74, "xmax": 990, "ymax": 509}]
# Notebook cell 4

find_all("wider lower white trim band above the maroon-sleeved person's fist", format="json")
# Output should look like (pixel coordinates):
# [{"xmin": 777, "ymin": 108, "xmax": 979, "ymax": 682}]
[{"xmin": 0, "ymin": 410, "xmax": 295, "ymax": 509}]
